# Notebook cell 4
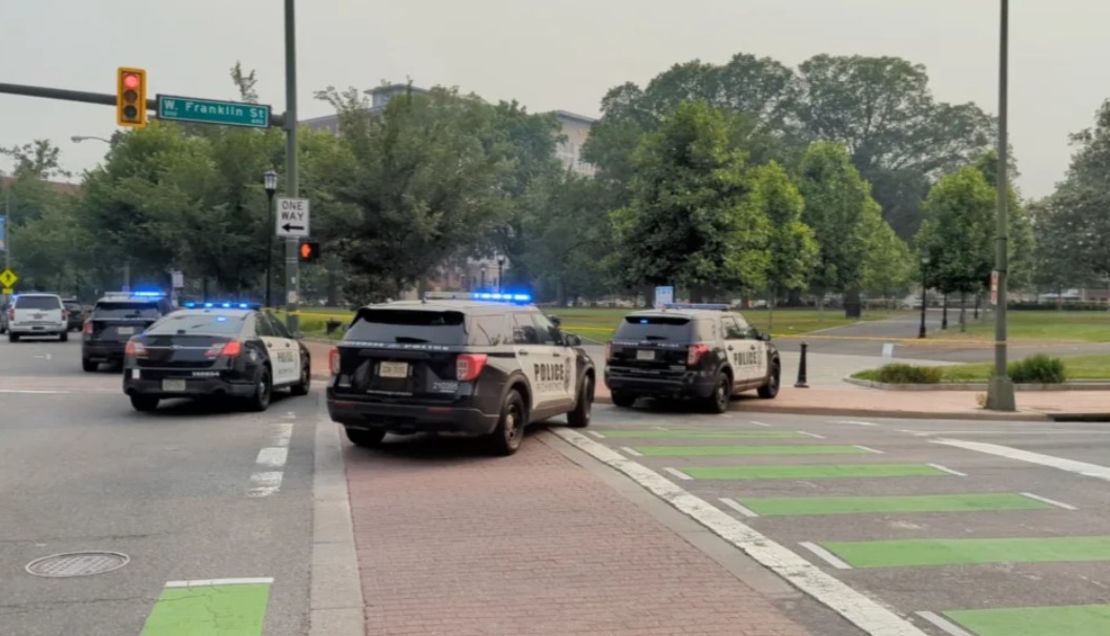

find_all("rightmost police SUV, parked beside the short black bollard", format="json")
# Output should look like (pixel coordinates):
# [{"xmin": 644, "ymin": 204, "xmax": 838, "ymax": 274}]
[{"xmin": 605, "ymin": 304, "xmax": 783, "ymax": 413}]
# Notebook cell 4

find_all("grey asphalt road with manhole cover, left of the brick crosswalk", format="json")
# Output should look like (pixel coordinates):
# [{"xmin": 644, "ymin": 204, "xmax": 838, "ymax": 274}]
[{"xmin": 0, "ymin": 339, "xmax": 320, "ymax": 636}]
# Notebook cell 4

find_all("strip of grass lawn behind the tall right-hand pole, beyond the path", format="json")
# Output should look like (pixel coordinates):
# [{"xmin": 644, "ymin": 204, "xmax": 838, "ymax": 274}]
[{"xmin": 944, "ymin": 310, "xmax": 1110, "ymax": 342}]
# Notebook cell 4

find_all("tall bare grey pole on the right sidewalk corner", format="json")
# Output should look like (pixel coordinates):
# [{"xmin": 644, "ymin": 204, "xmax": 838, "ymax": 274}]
[{"xmin": 987, "ymin": 0, "xmax": 1017, "ymax": 411}]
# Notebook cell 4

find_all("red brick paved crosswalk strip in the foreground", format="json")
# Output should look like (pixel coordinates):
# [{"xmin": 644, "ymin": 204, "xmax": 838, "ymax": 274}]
[{"xmin": 344, "ymin": 436, "xmax": 806, "ymax": 636}]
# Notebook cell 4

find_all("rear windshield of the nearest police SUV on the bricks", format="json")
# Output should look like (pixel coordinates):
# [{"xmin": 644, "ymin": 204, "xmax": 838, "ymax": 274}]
[{"xmin": 345, "ymin": 310, "xmax": 466, "ymax": 345}]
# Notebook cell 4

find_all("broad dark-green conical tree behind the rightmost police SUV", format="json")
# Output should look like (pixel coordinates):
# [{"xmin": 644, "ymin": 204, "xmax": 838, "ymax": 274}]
[{"xmin": 613, "ymin": 102, "xmax": 770, "ymax": 297}]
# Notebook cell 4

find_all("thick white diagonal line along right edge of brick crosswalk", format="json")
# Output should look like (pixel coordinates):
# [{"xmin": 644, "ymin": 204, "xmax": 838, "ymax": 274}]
[{"xmin": 553, "ymin": 428, "xmax": 926, "ymax": 636}]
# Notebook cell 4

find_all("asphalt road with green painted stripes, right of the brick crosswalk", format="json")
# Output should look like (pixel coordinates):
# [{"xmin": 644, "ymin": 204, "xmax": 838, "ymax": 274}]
[{"xmin": 587, "ymin": 402, "xmax": 1110, "ymax": 636}]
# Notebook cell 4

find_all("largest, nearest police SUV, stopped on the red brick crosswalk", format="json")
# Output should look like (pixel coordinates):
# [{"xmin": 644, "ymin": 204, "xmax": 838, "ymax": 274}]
[{"xmin": 327, "ymin": 292, "xmax": 595, "ymax": 455}]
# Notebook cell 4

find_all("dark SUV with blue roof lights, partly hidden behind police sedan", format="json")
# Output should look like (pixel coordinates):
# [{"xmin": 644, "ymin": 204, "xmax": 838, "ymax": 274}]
[{"xmin": 81, "ymin": 292, "xmax": 173, "ymax": 372}]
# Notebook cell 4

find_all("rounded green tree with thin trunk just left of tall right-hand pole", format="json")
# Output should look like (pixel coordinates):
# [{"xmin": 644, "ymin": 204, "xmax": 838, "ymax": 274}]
[{"xmin": 917, "ymin": 165, "xmax": 995, "ymax": 331}]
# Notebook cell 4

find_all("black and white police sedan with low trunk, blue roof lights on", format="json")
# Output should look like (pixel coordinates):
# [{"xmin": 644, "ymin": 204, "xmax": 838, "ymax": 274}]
[{"xmin": 123, "ymin": 302, "xmax": 312, "ymax": 411}]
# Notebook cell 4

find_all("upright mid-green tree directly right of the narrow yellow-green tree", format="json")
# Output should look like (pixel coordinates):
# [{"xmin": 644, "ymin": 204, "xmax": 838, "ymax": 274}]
[{"xmin": 798, "ymin": 142, "xmax": 876, "ymax": 311}]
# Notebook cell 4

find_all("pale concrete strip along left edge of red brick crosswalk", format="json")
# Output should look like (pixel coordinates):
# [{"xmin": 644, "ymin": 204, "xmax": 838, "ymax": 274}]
[{"xmin": 309, "ymin": 395, "xmax": 366, "ymax": 636}]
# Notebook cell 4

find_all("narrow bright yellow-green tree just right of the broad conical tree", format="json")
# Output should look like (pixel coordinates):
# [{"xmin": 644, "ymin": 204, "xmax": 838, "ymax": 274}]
[{"xmin": 746, "ymin": 161, "xmax": 820, "ymax": 317}]
